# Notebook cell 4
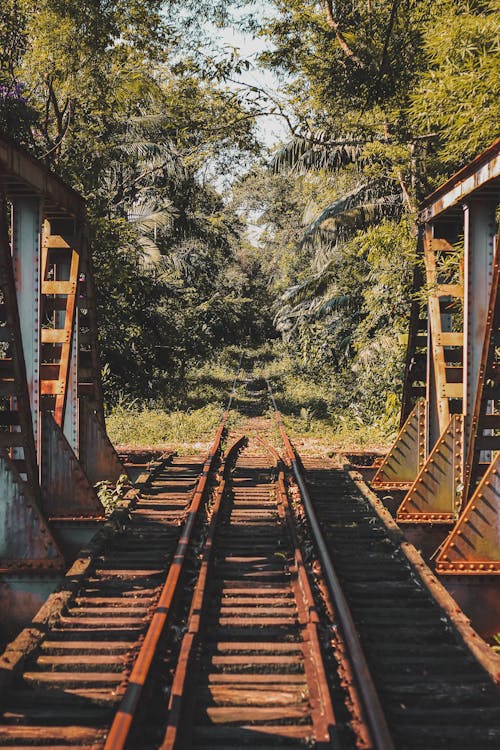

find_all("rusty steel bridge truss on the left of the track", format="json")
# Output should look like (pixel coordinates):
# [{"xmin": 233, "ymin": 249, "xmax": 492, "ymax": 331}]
[{"xmin": 0, "ymin": 139, "xmax": 124, "ymax": 632}]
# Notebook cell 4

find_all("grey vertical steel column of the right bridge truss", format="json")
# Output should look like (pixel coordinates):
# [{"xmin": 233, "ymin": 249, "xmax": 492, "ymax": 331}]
[{"xmin": 463, "ymin": 200, "xmax": 495, "ymax": 456}]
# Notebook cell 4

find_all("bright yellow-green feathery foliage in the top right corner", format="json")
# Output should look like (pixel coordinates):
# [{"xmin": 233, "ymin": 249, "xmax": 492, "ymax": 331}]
[{"xmin": 410, "ymin": 0, "xmax": 500, "ymax": 172}]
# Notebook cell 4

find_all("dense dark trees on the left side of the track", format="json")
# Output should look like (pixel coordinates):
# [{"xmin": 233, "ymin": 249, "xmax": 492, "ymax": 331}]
[{"xmin": 0, "ymin": 0, "xmax": 271, "ymax": 404}]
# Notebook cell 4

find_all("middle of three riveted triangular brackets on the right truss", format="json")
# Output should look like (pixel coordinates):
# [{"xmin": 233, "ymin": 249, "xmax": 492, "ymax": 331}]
[{"xmin": 397, "ymin": 414, "xmax": 464, "ymax": 523}]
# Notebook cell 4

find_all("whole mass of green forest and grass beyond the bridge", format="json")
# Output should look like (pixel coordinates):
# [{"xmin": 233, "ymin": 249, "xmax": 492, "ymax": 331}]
[{"xmin": 0, "ymin": 0, "xmax": 500, "ymax": 444}]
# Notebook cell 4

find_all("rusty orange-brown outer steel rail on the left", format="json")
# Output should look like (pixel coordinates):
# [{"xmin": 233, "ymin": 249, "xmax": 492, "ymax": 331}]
[{"xmin": 104, "ymin": 368, "xmax": 241, "ymax": 750}]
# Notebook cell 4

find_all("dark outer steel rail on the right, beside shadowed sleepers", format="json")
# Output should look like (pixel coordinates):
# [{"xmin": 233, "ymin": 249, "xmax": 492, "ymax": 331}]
[{"xmin": 266, "ymin": 378, "xmax": 395, "ymax": 750}]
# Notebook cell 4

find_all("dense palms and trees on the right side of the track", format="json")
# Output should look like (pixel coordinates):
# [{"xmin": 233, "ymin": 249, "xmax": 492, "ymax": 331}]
[{"xmin": 232, "ymin": 0, "xmax": 500, "ymax": 424}]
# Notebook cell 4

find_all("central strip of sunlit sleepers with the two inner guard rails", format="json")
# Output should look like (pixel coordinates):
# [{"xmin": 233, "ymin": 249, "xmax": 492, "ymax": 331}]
[{"xmin": 161, "ymin": 441, "xmax": 336, "ymax": 750}]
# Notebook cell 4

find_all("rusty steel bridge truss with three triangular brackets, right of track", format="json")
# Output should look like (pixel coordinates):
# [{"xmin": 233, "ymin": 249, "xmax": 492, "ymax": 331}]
[{"xmin": 373, "ymin": 140, "xmax": 500, "ymax": 575}]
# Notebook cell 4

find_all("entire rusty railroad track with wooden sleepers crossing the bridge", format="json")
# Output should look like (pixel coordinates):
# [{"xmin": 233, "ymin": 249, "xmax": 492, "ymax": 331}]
[{"xmin": 0, "ymin": 378, "xmax": 500, "ymax": 750}]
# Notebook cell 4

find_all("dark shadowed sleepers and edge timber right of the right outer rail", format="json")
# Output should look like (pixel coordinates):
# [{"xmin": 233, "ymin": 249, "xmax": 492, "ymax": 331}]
[{"xmin": 298, "ymin": 459, "xmax": 500, "ymax": 750}]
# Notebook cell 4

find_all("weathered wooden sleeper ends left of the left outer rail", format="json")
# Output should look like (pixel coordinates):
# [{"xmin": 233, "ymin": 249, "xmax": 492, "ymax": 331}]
[{"xmin": 0, "ymin": 458, "xmax": 202, "ymax": 748}]
